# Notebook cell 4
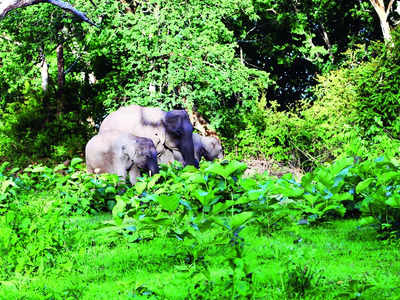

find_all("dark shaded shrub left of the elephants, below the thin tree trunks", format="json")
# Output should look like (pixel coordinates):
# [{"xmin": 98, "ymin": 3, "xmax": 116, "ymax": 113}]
[{"xmin": 0, "ymin": 85, "xmax": 94, "ymax": 166}]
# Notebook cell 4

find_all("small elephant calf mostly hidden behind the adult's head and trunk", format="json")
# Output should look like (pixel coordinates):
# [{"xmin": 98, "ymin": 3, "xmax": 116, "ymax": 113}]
[{"xmin": 158, "ymin": 133, "xmax": 224, "ymax": 164}]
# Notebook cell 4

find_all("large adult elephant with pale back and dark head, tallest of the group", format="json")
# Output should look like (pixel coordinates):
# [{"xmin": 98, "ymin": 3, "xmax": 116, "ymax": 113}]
[{"xmin": 99, "ymin": 105, "xmax": 199, "ymax": 168}]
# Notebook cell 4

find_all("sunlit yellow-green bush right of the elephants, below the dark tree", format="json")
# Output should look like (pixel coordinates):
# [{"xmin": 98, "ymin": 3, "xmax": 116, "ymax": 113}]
[{"xmin": 227, "ymin": 33, "xmax": 400, "ymax": 167}]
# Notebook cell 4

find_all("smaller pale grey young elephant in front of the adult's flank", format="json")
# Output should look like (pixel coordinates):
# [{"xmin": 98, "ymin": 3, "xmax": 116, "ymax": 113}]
[{"xmin": 85, "ymin": 131, "xmax": 159, "ymax": 184}]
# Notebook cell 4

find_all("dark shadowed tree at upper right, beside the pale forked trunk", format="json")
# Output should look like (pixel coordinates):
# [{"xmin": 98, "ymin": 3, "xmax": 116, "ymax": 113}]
[{"xmin": 226, "ymin": 0, "xmax": 379, "ymax": 106}]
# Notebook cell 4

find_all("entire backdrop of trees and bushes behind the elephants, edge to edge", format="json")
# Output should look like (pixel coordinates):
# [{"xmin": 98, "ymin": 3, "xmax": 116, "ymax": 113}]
[{"xmin": 0, "ymin": 0, "xmax": 399, "ymax": 167}]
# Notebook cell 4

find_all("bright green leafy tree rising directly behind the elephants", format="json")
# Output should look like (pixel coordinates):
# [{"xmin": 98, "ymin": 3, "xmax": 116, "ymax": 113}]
[{"xmin": 80, "ymin": 0, "xmax": 270, "ymax": 131}]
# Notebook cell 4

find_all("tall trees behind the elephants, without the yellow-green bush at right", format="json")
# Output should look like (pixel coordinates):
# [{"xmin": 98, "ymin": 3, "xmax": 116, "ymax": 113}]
[{"xmin": 0, "ymin": 0, "xmax": 399, "ymax": 165}]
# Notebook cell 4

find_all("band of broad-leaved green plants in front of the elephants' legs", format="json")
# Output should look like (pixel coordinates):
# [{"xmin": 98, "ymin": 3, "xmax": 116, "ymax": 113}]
[{"xmin": 0, "ymin": 157, "xmax": 400, "ymax": 295}]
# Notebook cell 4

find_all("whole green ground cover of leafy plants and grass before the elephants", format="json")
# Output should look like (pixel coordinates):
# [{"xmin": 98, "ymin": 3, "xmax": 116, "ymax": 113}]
[{"xmin": 0, "ymin": 157, "xmax": 400, "ymax": 299}]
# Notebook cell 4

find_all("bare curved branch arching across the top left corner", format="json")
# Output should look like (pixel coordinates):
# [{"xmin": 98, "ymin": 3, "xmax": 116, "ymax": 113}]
[{"xmin": 0, "ymin": 0, "xmax": 98, "ymax": 27}]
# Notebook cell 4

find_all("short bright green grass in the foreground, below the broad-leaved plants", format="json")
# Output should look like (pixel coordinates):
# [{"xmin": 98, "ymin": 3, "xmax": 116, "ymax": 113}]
[{"xmin": 0, "ymin": 214, "xmax": 400, "ymax": 299}]
